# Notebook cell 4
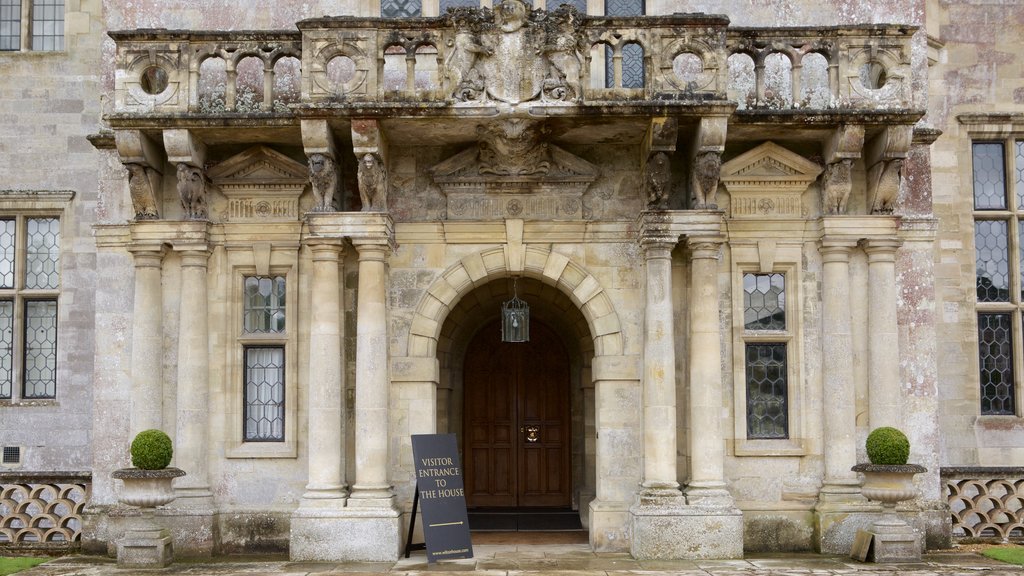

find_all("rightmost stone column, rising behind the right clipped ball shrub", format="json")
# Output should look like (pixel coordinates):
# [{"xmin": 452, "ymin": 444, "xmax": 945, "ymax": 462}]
[{"xmin": 864, "ymin": 239, "xmax": 900, "ymax": 428}]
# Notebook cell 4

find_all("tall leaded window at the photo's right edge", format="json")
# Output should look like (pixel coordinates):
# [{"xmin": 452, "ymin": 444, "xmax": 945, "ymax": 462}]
[{"xmin": 971, "ymin": 138, "xmax": 1024, "ymax": 414}]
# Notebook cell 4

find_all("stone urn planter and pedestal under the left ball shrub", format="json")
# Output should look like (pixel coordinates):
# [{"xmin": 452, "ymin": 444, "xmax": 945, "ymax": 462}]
[{"xmin": 111, "ymin": 468, "xmax": 185, "ymax": 568}]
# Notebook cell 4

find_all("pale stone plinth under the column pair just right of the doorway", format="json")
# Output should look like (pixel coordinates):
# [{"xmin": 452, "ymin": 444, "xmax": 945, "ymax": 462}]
[{"xmin": 630, "ymin": 496, "xmax": 743, "ymax": 560}]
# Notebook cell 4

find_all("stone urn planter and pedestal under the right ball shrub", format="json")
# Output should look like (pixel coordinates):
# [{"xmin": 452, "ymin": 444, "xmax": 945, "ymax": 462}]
[{"xmin": 850, "ymin": 464, "xmax": 928, "ymax": 563}]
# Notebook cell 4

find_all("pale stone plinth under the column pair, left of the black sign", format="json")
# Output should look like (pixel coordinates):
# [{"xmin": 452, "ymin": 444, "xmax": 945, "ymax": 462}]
[{"xmin": 289, "ymin": 500, "xmax": 401, "ymax": 562}]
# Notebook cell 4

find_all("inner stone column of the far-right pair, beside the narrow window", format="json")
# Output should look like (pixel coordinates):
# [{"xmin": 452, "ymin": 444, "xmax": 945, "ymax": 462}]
[{"xmin": 819, "ymin": 238, "xmax": 860, "ymax": 501}]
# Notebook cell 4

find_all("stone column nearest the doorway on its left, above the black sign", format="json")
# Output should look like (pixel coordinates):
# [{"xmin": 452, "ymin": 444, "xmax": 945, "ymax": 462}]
[{"xmin": 348, "ymin": 240, "xmax": 394, "ymax": 507}]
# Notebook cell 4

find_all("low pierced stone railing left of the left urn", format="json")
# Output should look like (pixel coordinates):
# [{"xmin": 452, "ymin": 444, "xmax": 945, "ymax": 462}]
[{"xmin": 0, "ymin": 471, "xmax": 92, "ymax": 551}]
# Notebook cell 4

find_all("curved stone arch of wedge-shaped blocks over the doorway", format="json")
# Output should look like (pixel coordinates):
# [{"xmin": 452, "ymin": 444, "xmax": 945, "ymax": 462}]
[{"xmin": 408, "ymin": 246, "xmax": 623, "ymax": 358}]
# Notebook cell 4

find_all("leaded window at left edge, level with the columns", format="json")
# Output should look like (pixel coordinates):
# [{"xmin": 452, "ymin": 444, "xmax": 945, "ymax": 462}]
[{"xmin": 0, "ymin": 215, "xmax": 60, "ymax": 400}]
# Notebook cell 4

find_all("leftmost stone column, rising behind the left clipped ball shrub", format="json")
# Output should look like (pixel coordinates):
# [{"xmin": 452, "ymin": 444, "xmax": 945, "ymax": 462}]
[{"xmin": 129, "ymin": 244, "xmax": 164, "ymax": 438}]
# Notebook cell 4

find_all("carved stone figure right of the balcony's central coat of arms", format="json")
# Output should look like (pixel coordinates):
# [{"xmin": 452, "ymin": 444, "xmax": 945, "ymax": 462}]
[{"xmin": 542, "ymin": 4, "xmax": 583, "ymax": 100}]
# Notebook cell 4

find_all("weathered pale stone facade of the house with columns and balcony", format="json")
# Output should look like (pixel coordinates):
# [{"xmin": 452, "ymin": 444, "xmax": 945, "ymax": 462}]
[{"xmin": 0, "ymin": 0, "xmax": 1024, "ymax": 560}]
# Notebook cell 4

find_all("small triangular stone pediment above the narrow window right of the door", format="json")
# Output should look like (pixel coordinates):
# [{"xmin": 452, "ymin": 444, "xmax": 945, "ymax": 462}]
[{"xmin": 721, "ymin": 142, "xmax": 821, "ymax": 189}]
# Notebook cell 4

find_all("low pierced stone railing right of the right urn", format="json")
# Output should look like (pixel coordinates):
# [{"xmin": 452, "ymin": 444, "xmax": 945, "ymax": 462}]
[{"xmin": 940, "ymin": 467, "xmax": 1024, "ymax": 541}]
